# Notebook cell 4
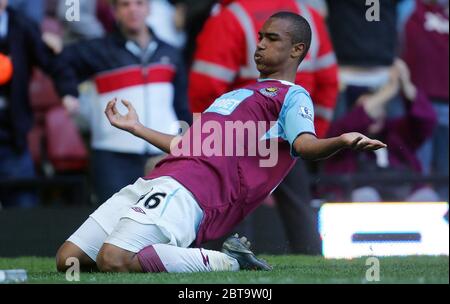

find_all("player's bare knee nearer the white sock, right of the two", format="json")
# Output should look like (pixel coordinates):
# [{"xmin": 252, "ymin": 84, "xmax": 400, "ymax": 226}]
[{"xmin": 97, "ymin": 244, "xmax": 141, "ymax": 272}]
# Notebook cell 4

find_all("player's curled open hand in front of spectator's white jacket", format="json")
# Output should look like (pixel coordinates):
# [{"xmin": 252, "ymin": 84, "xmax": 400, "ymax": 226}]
[{"xmin": 105, "ymin": 98, "xmax": 140, "ymax": 133}]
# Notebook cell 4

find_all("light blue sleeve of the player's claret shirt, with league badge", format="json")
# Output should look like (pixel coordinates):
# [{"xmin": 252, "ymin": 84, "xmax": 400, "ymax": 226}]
[{"xmin": 280, "ymin": 90, "xmax": 316, "ymax": 155}]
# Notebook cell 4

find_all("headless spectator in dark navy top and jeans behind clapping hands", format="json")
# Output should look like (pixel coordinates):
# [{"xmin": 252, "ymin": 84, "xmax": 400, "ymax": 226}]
[{"xmin": 327, "ymin": 0, "xmax": 408, "ymax": 118}]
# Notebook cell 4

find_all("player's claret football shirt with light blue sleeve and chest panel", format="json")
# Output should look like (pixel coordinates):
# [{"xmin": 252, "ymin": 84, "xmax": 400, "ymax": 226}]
[{"xmin": 147, "ymin": 79, "xmax": 315, "ymax": 245}]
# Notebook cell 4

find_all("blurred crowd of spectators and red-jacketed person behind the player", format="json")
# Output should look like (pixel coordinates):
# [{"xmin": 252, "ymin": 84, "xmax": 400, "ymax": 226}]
[{"xmin": 0, "ymin": 0, "xmax": 449, "ymax": 250}]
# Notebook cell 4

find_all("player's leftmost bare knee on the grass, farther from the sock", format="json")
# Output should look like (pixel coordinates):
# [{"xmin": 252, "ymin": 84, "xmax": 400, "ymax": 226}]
[{"xmin": 56, "ymin": 242, "xmax": 96, "ymax": 272}]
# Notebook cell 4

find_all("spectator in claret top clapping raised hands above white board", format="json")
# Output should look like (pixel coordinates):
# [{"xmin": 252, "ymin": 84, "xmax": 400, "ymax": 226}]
[{"xmin": 325, "ymin": 60, "xmax": 436, "ymax": 201}]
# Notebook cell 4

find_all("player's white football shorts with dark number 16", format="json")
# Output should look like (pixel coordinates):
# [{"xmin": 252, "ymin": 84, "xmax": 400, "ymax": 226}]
[{"xmin": 68, "ymin": 177, "xmax": 203, "ymax": 261}]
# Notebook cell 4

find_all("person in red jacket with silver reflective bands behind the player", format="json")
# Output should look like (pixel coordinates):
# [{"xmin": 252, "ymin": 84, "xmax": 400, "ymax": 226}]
[{"xmin": 188, "ymin": 0, "xmax": 338, "ymax": 254}]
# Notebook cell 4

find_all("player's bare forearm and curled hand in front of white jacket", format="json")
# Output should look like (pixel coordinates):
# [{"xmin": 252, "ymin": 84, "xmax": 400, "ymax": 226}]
[{"xmin": 105, "ymin": 98, "xmax": 175, "ymax": 153}]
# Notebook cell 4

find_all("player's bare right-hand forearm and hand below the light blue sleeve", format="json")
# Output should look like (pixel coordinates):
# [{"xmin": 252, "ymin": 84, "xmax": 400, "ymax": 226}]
[{"xmin": 294, "ymin": 132, "xmax": 387, "ymax": 160}]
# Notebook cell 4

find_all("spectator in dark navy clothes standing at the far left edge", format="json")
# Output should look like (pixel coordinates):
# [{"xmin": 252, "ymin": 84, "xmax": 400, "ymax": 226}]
[{"xmin": 0, "ymin": 0, "xmax": 60, "ymax": 207}]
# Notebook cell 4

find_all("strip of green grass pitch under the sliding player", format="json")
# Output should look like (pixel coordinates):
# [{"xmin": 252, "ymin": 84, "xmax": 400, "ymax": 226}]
[{"xmin": 0, "ymin": 256, "xmax": 449, "ymax": 284}]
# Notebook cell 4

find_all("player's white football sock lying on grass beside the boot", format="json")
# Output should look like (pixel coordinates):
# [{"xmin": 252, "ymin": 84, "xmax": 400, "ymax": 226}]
[{"xmin": 149, "ymin": 244, "xmax": 239, "ymax": 273}]
